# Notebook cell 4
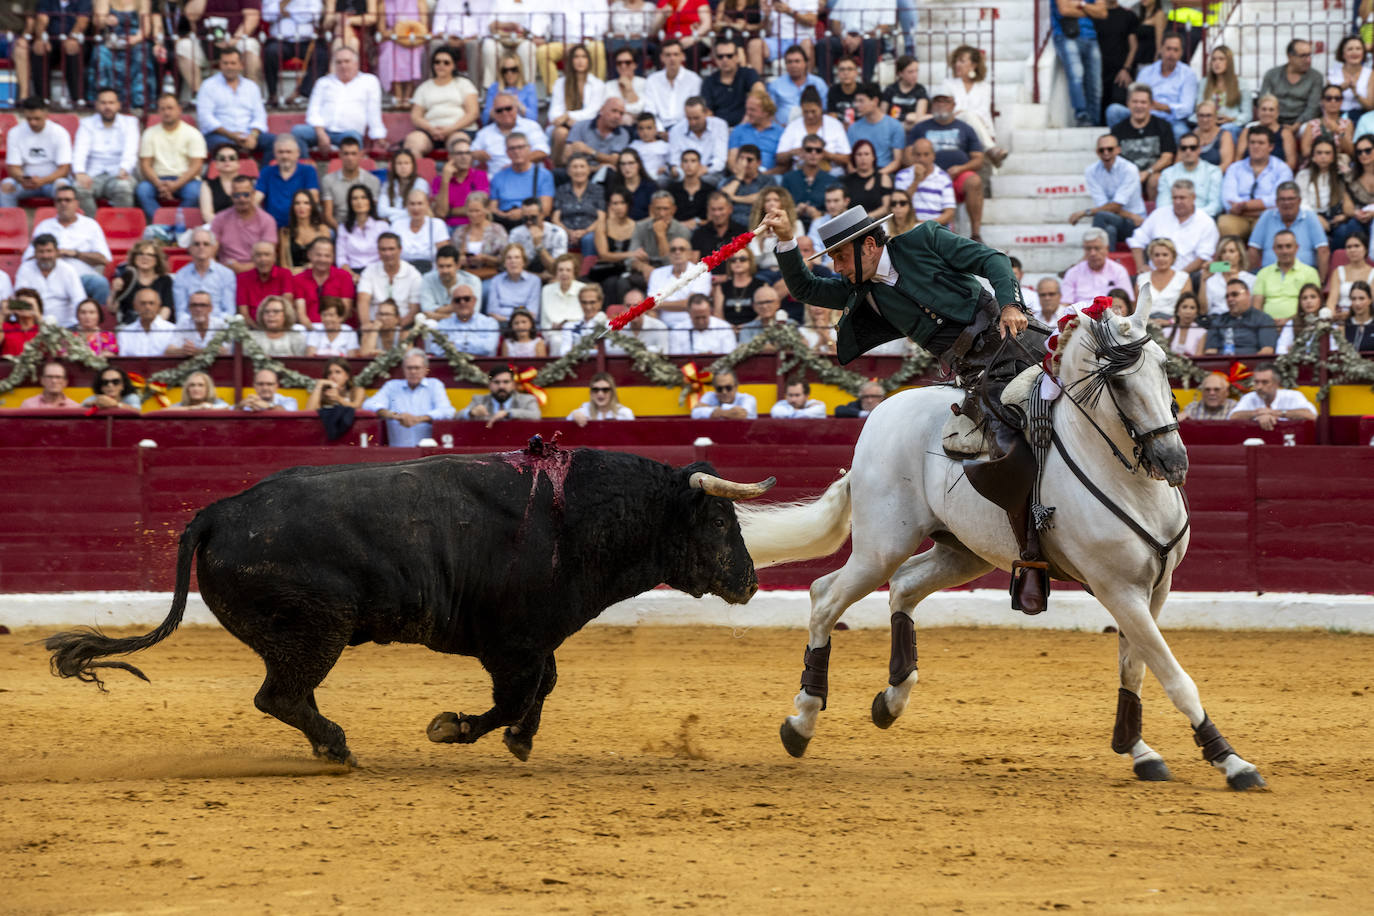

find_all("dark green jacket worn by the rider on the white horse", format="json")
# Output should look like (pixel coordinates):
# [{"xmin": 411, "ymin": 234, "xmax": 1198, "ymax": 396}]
[{"xmin": 778, "ymin": 220, "xmax": 1025, "ymax": 363}]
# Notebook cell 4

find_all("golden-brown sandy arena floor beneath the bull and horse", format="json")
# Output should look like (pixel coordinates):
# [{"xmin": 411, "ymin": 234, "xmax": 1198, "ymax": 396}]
[{"xmin": 0, "ymin": 628, "xmax": 1374, "ymax": 916}]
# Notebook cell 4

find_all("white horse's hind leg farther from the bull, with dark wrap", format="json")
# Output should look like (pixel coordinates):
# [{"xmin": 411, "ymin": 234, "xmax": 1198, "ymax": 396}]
[{"xmin": 871, "ymin": 542, "xmax": 992, "ymax": 728}]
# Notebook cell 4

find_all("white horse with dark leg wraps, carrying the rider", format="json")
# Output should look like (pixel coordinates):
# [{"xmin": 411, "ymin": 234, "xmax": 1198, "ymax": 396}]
[{"xmin": 735, "ymin": 308, "xmax": 1264, "ymax": 790}]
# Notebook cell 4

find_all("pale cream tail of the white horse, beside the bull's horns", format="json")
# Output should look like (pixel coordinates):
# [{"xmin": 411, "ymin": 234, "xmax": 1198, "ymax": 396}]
[{"xmin": 735, "ymin": 474, "xmax": 849, "ymax": 569}]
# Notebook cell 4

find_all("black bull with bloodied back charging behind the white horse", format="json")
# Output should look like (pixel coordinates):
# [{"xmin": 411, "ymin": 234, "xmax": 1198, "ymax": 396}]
[{"xmin": 45, "ymin": 437, "xmax": 772, "ymax": 764}]
